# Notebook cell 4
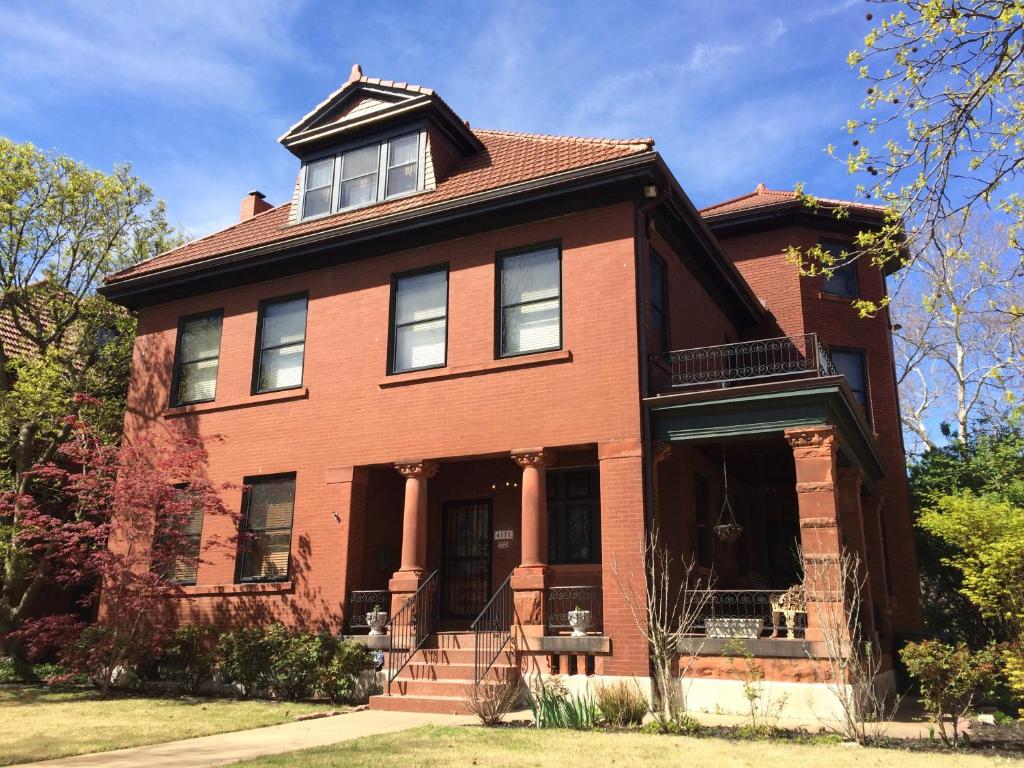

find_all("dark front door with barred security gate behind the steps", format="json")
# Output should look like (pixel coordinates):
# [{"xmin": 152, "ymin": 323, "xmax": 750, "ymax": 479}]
[{"xmin": 440, "ymin": 501, "xmax": 490, "ymax": 618}]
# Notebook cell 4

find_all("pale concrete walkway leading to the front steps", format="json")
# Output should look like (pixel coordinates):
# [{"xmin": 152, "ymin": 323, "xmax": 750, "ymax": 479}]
[{"xmin": 20, "ymin": 710, "xmax": 476, "ymax": 768}]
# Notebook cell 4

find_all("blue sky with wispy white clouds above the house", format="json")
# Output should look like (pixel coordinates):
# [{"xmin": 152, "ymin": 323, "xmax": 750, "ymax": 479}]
[{"xmin": 0, "ymin": 0, "xmax": 868, "ymax": 236}]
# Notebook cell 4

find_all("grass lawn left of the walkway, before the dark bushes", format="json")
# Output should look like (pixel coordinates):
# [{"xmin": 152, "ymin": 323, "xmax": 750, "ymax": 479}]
[{"xmin": 0, "ymin": 686, "xmax": 337, "ymax": 765}]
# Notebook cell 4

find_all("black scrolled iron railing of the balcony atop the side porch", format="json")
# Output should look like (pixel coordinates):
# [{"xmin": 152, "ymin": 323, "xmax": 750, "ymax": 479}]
[{"xmin": 651, "ymin": 334, "xmax": 839, "ymax": 389}]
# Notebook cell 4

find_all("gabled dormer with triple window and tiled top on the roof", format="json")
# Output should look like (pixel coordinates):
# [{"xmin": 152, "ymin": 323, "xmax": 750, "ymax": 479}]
[{"xmin": 279, "ymin": 65, "xmax": 483, "ymax": 223}]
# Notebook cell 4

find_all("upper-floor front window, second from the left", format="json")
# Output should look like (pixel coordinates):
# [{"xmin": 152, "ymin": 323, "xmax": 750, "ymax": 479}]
[{"xmin": 253, "ymin": 296, "xmax": 306, "ymax": 394}]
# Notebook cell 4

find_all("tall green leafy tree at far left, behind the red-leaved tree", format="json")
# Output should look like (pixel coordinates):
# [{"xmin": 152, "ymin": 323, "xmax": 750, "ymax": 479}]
[{"xmin": 0, "ymin": 137, "xmax": 180, "ymax": 643}]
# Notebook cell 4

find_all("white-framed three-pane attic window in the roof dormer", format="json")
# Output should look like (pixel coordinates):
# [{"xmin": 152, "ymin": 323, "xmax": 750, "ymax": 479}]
[{"xmin": 302, "ymin": 132, "xmax": 424, "ymax": 219}]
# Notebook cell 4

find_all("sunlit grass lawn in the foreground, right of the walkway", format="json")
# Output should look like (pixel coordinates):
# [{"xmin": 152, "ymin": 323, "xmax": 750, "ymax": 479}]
[{"xmin": 236, "ymin": 727, "xmax": 1022, "ymax": 768}]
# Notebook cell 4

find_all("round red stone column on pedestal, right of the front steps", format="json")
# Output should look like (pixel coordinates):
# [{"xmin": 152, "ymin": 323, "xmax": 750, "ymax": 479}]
[{"xmin": 510, "ymin": 449, "xmax": 552, "ymax": 636}]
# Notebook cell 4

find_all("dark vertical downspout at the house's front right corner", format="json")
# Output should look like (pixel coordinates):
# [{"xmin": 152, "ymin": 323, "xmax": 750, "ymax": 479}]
[{"xmin": 633, "ymin": 184, "xmax": 664, "ymax": 537}]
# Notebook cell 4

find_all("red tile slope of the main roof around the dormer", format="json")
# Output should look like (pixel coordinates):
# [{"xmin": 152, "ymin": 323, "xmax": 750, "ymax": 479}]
[{"xmin": 105, "ymin": 129, "xmax": 654, "ymax": 284}]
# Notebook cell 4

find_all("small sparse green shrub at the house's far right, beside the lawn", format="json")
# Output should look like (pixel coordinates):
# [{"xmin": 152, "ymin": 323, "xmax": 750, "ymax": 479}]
[{"xmin": 900, "ymin": 640, "xmax": 999, "ymax": 749}]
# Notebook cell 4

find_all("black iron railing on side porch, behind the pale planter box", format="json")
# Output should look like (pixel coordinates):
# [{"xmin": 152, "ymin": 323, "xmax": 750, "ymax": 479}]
[{"xmin": 692, "ymin": 590, "xmax": 807, "ymax": 639}]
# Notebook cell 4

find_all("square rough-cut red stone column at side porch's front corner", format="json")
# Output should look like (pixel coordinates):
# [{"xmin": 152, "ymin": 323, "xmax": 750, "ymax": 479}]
[{"xmin": 785, "ymin": 426, "xmax": 845, "ymax": 641}]
